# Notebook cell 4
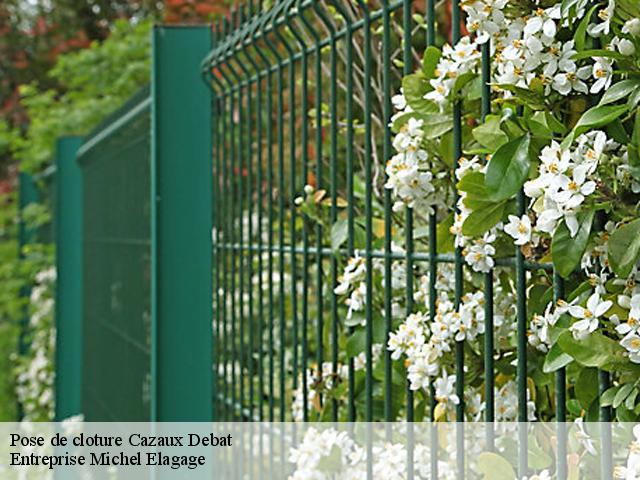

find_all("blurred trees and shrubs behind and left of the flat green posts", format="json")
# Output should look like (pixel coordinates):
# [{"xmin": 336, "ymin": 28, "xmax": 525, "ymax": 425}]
[{"xmin": 0, "ymin": 0, "xmax": 230, "ymax": 421}]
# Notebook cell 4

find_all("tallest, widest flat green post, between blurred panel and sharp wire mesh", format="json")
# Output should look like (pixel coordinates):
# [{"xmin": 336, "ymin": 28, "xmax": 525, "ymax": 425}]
[{"xmin": 151, "ymin": 26, "xmax": 213, "ymax": 421}]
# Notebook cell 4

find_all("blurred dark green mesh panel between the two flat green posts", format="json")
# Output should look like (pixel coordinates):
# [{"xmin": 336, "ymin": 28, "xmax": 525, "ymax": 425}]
[{"xmin": 79, "ymin": 90, "xmax": 151, "ymax": 421}]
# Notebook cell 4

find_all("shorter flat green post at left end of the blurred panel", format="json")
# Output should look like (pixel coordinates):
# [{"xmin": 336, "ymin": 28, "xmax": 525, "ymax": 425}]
[{"xmin": 54, "ymin": 137, "xmax": 82, "ymax": 421}]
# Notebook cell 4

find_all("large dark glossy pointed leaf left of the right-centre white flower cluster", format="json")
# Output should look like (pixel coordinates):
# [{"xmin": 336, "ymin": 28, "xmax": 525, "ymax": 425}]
[{"xmin": 485, "ymin": 135, "xmax": 531, "ymax": 201}]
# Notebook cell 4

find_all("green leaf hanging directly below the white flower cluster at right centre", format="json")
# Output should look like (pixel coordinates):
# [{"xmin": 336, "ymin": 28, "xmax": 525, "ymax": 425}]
[{"xmin": 551, "ymin": 210, "xmax": 595, "ymax": 278}]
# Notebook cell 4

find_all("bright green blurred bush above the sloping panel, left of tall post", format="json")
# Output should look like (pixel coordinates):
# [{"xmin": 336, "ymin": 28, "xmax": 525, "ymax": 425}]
[{"xmin": 12, "ymin": 20, "xmax": 151, "ymax": 173}]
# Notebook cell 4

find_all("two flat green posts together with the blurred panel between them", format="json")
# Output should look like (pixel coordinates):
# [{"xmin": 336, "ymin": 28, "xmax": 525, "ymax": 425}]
[{"xmin": 55, "ymin": 26, "xmax": 213, "ymax": 421}]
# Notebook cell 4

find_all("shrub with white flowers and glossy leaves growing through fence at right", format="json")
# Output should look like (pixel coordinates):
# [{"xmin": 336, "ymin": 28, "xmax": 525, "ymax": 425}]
[{"xmin": 296, "ymin": 0, "xmax": 640, "ymax": 421}]
